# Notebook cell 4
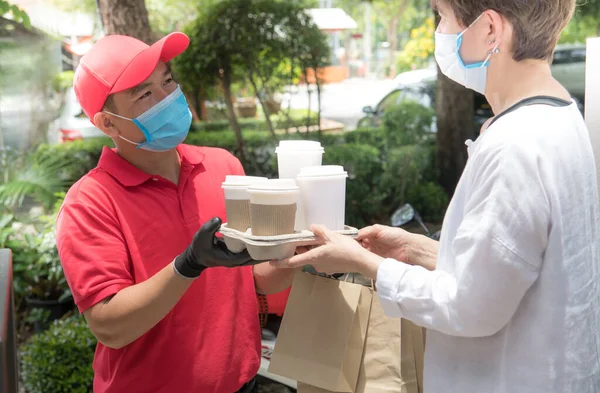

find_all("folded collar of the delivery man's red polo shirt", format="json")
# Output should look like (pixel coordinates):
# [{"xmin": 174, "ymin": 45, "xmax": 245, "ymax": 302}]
[{"xmin": 98, "ymin": 145, "xmax": 204, "ymax": 187}]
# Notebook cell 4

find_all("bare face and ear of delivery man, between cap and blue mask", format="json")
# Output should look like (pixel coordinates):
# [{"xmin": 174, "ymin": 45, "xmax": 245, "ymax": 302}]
[{"xmin": 94, "ymin": 62, "xmax": 177, "ymax": 146}]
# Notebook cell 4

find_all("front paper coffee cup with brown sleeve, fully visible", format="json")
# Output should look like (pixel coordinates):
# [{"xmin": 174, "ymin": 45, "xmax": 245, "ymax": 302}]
[{"xmin": 248, "ymin": 179, "xmax": 298, "ymax": 236}]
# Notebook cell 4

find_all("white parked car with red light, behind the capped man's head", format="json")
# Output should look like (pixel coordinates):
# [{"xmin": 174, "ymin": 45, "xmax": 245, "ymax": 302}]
[{"xmin": 48, "ymin": 88, "xmax": 104, "ymax": 143}]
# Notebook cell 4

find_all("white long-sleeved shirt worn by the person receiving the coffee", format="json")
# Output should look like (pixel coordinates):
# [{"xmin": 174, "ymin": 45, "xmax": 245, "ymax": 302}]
[{"xmin": 377, "ymin": 105, "xmax": 600, "ymax": 393}]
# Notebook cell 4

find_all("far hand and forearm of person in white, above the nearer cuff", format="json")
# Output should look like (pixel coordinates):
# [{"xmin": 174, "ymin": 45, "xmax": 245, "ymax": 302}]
[{"xmin": 357, "ymin": 225, "xmax": 439, "ymax": 270}]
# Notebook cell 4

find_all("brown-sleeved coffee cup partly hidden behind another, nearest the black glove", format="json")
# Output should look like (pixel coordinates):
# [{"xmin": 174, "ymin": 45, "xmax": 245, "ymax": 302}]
[{"xmin": 222, "ymin": 176, "xmax": 267, "ymax": 232}]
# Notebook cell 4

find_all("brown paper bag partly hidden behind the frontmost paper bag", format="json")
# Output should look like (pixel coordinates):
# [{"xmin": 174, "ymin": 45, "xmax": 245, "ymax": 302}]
[{"xmin": 298, "ymin": 295, "xmax": 424, "ymax": 393}]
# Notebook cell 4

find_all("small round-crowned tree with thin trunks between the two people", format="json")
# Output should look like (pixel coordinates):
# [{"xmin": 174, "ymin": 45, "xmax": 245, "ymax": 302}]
[{"xmin": 174, "ymin": 0, "xmax": 329, "ymax": 149}]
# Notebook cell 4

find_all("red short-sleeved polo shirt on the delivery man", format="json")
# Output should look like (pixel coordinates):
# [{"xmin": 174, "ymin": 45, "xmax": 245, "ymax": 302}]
[{"xmin": 56, "ymin": 145, "xmax": 260, "ymax": 393}]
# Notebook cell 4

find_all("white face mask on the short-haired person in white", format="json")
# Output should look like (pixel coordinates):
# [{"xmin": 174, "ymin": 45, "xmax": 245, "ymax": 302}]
[{"xmin": 435, "ymin": 14, "xmax": 500, "ymax": 94}]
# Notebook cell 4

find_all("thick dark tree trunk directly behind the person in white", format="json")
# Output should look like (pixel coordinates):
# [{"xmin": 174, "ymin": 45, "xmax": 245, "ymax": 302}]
[{"xmin": 436, "ymin": 69, "xmax": 474, "ymax": 197}]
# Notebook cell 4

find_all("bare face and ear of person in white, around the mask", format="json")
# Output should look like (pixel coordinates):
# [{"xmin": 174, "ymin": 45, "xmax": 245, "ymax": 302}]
[{"xmin": 437, "ymin": 0, "xmax": 493, "ymax": 64}]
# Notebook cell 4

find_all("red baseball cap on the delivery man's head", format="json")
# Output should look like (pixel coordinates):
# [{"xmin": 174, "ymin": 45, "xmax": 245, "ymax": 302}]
[{"xmin": 73, "ymin": 33, "xmax": 190, "ymax": 123}]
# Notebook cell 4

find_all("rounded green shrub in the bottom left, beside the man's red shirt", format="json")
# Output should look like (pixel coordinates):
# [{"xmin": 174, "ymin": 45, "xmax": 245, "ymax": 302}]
[{"xmin": 21, "ymin": 316, "xmax": 97, "ymax": 393}]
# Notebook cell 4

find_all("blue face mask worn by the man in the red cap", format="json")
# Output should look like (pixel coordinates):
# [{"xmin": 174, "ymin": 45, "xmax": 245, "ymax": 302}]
[{"xmin": 106, "ymin": 86, "xmax": 192, "ymax": 151}]
